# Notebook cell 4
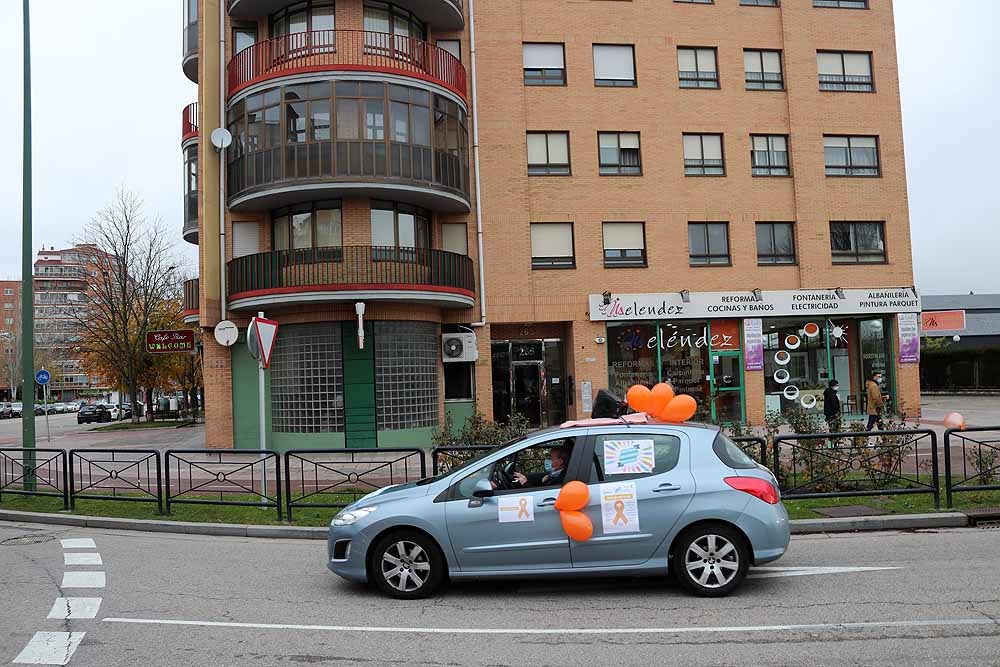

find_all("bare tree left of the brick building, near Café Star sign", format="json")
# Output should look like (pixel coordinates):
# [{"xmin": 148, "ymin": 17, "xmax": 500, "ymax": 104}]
[{"xmin": 69, "ymin": 189, "xmax": 177, "ymax": 423}]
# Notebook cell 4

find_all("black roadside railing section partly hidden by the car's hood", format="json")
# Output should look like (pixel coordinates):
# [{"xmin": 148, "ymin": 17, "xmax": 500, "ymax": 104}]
[{"xmin": 285, "ymin": 447, "xmax": 427, "ymax": 521}]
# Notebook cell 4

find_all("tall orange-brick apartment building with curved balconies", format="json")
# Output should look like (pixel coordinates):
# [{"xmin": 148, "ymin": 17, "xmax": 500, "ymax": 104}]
[{"xmin": 182, "ymin": 0, "xmax": 920, "ymax": 449}]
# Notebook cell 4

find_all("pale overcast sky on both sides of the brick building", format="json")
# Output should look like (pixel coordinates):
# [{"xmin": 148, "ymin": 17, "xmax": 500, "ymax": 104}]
[{"xmin": 0, "ymin": 0, "xmax": 1000, "ymax": 294}]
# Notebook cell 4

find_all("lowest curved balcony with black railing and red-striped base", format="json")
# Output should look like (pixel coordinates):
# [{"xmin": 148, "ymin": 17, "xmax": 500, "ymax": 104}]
[{"xmin": 226, "ymin": 246, "xmax": 475, "ymax": 310}]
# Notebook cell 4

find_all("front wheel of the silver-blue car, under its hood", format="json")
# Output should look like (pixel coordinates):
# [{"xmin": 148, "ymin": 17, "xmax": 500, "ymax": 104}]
[{"xmin": 369, "ymin": 530, "xmax": 445, "ymax": 600}]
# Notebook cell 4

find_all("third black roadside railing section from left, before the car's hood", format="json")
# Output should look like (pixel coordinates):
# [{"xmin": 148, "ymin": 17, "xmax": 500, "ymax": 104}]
[{"xmin": 164, "ymin": 449, "xmax": 282, "ymax": 521}]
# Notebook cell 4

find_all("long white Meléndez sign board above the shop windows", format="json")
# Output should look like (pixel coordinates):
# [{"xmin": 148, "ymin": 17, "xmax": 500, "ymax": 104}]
[{"xmin": 589, "ymin": 288, "xmax": 920, "ymax": 322}]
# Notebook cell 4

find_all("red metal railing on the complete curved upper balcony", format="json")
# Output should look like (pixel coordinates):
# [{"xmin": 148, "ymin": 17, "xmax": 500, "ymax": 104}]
[{"xmin": 228, "ymin": 30, "xmax": 466, "ymax": 98}]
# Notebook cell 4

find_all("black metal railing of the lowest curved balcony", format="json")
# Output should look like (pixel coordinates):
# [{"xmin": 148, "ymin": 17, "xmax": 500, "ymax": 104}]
[{"xmin": 226, "ymin": 246, "xmax": 475, "ymax": 296}]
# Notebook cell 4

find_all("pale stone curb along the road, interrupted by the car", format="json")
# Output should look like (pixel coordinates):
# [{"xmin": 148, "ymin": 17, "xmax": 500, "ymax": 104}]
[{"xmin": 0, "ymin": 510, "xmax": 969, "ymax": 540}]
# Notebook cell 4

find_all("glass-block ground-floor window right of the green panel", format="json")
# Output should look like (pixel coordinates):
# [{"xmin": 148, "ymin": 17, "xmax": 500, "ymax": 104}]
[{"xmin": 375, "ymin": 322, "xmax": 441, "ymax": 431}]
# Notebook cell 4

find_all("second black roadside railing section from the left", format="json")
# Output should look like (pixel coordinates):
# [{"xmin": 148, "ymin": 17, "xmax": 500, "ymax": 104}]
[{"xmin": 69, "ymin": 449, "xmax": 163, "ymax": 514}]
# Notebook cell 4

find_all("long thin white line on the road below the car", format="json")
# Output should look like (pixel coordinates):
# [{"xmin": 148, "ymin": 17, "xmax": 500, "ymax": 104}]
[{"xmin": 104, "ymin": 618, "xmax": 997, "ymax": 635}]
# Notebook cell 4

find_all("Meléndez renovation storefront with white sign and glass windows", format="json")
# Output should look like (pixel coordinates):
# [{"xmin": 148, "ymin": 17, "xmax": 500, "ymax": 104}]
[{"xmin": 590, "ymin": 288, "xmax": 920, "ymax": 423}]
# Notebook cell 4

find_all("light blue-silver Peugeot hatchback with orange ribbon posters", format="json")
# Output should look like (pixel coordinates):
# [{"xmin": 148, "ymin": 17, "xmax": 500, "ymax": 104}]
[{"xmin": 327, "ymin": 422, "xmax": 789, "ymax": 598}]
